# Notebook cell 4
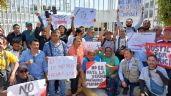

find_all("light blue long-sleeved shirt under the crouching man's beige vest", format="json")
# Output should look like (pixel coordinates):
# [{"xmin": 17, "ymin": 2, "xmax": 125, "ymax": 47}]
[{"xmin": 119, "ymin": 57, "xmax": 143, "ymax": 81}]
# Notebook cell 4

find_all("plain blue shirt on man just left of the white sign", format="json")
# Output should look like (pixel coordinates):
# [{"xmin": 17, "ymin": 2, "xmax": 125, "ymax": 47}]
[{"xmin": 19, "ymin": 49, "xmax": 48, "ymax": 79}]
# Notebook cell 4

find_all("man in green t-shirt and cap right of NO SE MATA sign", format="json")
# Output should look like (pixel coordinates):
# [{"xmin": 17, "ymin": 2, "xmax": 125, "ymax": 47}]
[{"xmin": 98, "ymin": 47, "xmax": 119, "ymax": 96}]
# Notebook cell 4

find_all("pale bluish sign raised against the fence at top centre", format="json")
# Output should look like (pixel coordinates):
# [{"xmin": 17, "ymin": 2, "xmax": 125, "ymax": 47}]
[{"xmin": 74, "ymin": 7, "xmax": 96, "ymax": 26}]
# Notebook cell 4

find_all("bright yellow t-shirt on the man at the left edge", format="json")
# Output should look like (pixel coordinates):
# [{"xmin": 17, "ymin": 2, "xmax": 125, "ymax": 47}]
[{"xmin": 0, "ymin": 51, "xmax": 18, "ymax": 69}]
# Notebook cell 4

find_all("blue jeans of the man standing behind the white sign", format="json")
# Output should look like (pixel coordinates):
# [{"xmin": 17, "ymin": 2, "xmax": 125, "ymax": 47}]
[{"xmin": 48, "ymin": 80, "xmax": 66, "ymax": 96}]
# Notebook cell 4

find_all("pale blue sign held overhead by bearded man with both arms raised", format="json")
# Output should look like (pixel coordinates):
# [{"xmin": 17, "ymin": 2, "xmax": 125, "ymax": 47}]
[{"xmin": 118, "ymin": 0, "xmax": 143, "ymax": 17}]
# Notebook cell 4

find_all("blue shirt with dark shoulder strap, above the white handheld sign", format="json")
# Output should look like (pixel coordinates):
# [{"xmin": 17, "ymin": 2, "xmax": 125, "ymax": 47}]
[{"xmin": 43, "ymin": 40, "xmax": 67, "ymax": 56}]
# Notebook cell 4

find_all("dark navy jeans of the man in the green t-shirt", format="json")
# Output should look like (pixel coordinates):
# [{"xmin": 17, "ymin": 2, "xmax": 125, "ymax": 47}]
[{"xmin": 106, "ymin": 77, "xmax": 118, "ymax": 96}]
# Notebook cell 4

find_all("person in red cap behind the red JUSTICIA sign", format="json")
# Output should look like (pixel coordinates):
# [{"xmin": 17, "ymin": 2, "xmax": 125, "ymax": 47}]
[{"xmin": 157, "ymin": 27, "xmax": 171, "ymax": 96}]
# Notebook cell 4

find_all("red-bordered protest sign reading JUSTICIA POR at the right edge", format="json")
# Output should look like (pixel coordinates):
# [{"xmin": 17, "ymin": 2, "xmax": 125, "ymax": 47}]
[{"xmin": 146, "ymin": 43, "xmax": 171, "ymax": 69}]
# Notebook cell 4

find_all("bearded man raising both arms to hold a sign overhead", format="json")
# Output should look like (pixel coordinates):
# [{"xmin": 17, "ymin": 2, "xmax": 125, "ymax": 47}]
[{"xmin": 116, "ymin": 7, "xmax": 144, "ymax": 32}]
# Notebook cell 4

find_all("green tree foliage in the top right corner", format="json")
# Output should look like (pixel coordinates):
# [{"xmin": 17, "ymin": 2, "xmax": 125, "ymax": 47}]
[{"xmin": 157, "ymin": 0, "xmax": 171, "ymax": 26}]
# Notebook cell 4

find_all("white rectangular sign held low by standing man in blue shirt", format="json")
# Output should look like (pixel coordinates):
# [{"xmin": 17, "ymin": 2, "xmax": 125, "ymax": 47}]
[{"xmin": 48, "ymin": 56, "xmax": 77, "ymax": 80}]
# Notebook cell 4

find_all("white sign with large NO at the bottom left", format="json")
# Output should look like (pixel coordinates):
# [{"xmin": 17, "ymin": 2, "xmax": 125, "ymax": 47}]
[{"xmin": 7, "ymin": 79, "xmax": 46, "ymax": 96}]
